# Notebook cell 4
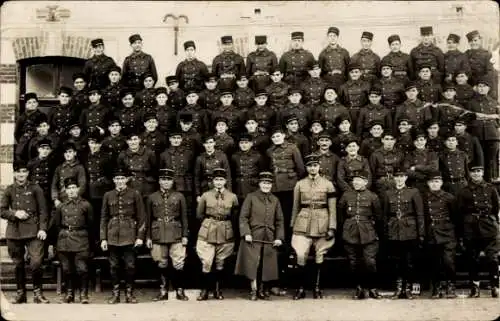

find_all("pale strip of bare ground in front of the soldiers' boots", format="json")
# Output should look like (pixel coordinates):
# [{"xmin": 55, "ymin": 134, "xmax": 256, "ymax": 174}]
[{"xmin": 2, "ymin": 289, "xmax": 500, "ymax": 321}]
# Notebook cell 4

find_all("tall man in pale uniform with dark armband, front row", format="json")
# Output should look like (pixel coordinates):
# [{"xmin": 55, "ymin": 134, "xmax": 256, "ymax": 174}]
[{"xmin": 290, "ymin": 155, "xmax": 337, "ymax": 300}]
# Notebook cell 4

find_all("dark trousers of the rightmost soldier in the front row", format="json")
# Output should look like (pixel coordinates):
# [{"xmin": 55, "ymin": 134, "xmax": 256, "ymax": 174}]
[{"xmin": 464, "ymin": 238, "xmax": 500, "ymax": 286}]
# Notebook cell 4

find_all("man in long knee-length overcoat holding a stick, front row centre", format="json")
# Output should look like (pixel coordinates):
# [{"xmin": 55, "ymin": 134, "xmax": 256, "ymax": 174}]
[{"xmin": 235, "ymin": 172, "xmax": 285, "ymax": 301}]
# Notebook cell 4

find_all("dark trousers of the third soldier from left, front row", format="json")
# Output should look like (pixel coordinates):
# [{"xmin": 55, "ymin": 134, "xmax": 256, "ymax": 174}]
[{"xmin": 108, "ymin": 244, "xmax": 136, "ymax": 287}]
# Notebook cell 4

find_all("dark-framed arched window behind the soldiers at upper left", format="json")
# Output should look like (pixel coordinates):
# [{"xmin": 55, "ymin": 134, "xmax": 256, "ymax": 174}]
[{"xmin": 19, "ymin": 56, "xmax": 85, "ymax": 112}]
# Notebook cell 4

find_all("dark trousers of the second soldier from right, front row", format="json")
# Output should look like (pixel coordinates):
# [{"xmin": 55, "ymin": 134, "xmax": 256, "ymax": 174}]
[{"xmin": 422, "ymin": 241, "xmax": 457, "ymax": 283}]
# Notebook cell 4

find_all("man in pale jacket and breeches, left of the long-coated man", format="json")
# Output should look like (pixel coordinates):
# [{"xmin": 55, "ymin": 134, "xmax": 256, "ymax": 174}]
[{"xmin": 196, "ymin": 168, "xmax": 239, "ymax": 301}]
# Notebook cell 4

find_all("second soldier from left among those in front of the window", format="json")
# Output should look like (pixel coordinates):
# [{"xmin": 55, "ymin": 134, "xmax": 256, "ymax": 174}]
[{"xmin": 48, "ymin": 86, "xmax": 77, "ymax": 139}]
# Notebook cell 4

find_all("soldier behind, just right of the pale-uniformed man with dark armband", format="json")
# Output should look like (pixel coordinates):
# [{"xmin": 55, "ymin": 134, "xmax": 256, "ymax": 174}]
[{"xmin": 336, "ymin": 138, "xmax": 372, "ymax": 194}]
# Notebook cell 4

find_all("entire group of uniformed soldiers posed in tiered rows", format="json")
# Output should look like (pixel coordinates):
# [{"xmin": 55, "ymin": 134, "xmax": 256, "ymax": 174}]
[{"xmin": 0, "ymin": 27, "xmax": 500, "ymax": 303}]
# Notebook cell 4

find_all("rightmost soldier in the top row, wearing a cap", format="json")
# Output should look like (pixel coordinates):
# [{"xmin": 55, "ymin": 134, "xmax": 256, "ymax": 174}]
[{"xmin": 465, "ymin": 30, "xmax": 498, "ymax": 100}]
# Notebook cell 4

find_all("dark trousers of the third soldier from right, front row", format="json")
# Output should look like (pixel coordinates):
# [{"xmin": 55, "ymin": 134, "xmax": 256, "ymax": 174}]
[{"xmin": 389, "ymin": 240, "xmax": 418, "ymax": 283}]
